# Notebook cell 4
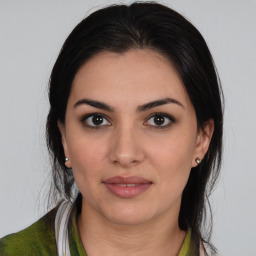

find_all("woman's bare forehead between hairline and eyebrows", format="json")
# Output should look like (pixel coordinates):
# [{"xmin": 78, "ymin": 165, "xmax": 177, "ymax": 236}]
[{"xmin": 70, "ymin": 49, "xmax": 190, "ymax": 109}]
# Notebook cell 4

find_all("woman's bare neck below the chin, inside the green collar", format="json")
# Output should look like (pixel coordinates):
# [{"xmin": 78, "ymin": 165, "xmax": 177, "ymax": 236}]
[{"xmin": 78, "ymin": 202, "xmax": 186, "ymax": 256}]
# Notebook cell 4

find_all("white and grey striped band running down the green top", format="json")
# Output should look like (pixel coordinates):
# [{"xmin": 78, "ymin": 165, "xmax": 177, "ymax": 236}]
[{"xmin": 55, "ymin": 201, "xmax": 73, "ymax": 256}]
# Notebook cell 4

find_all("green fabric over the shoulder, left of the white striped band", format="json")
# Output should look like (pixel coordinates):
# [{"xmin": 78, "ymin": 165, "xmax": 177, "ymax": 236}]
[{"xmin": 0, "ymin": 207, "xmax": 57, "ymax": 256}]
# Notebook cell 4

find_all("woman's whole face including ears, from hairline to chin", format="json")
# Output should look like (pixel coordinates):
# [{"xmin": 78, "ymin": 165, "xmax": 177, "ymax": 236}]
[{"xmin": 59, "ymin": 50, "xmax": 213, "ymax": 225}]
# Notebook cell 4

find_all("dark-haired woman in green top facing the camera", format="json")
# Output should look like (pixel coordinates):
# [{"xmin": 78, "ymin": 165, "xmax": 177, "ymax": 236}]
[{"xmin": 0, "ymin": 3, "xmax": 223, "ymax": 256}]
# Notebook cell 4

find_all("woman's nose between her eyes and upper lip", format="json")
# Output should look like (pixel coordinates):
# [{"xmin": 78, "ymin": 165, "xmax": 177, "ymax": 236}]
[{"xmin": 110, "ymin": 124, "xmax": 145, "ymax": 168}]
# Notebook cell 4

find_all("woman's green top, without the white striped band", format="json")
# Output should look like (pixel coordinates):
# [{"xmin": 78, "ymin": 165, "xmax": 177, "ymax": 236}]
[{"xmin": 0, "ymin": 203, "xmax": 198, "ymax": 256}]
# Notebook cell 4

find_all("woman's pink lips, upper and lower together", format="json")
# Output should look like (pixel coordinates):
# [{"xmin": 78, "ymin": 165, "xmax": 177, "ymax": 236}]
[{"xmin": 103, "ymin": 176, "xmax": 152, "ymax": 198}]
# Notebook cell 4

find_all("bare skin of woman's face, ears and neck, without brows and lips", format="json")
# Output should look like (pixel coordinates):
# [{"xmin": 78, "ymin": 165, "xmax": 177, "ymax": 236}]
[{"xmin": 58, "ymin": 49, "xmax": 213, "ymax": 256}]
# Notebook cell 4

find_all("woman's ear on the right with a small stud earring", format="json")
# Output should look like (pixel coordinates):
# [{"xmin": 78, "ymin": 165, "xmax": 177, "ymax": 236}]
[{"xmin": 192, "ymin": 119, "xmax": 214, "ymax": 167}]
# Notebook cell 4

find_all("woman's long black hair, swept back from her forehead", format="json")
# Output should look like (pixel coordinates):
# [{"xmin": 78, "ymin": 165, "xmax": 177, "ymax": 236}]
[{"xmin": 47, "ymin": 2, "xmax": 223, "ymax": 254}]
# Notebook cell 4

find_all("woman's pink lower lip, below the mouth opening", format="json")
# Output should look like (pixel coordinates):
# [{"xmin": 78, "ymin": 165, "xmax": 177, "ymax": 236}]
[{"xmin": 104, "ymin": 183, "xmax": 152, "ymax": 198}]
